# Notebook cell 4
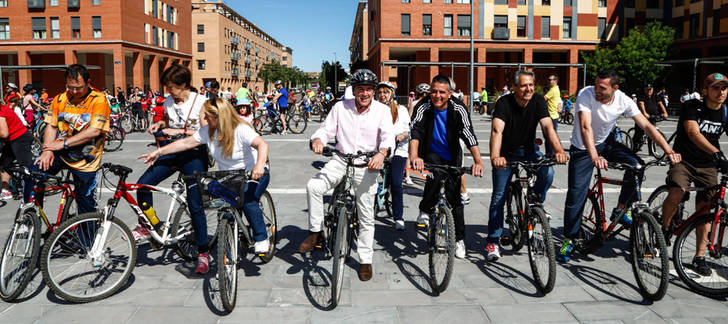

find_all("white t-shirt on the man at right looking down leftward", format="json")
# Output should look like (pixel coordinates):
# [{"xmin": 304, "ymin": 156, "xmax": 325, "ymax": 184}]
[{"xmin": 571, "ymin": 86, "xmax": 640, "ymax": 150}]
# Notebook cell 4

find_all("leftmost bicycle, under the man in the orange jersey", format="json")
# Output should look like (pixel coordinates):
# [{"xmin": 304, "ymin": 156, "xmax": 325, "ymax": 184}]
[{"xmin": 0, "ymin": 168, "xmax": 76, "ymax": 301}]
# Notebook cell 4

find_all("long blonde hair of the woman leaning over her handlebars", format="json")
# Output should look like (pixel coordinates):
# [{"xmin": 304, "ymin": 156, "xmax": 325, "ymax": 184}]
[{"xmin": 202, "ymin": 98, "xmax": 252, "ymax": 158}]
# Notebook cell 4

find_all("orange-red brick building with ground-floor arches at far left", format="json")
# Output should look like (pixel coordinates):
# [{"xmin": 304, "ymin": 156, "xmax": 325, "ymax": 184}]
[{"xmin": 0, "ymin": 0, "xmax": 192, "ymax": 94}]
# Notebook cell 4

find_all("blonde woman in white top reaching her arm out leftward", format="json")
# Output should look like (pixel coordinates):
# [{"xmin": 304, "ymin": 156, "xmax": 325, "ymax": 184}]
[{"xmin": 140, "ymin": 98, "xmax": 270, "ymax": 253}]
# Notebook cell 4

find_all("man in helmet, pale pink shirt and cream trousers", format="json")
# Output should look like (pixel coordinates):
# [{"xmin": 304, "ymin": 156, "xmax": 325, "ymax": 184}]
[{"xmin": 298, "ymin": 69, "xmax": 395, "ymax": 281}]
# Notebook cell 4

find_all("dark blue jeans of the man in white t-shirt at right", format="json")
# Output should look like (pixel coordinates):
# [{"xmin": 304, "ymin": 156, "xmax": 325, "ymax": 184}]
[{"xmin": 564, "ymin": 133, "xmax": 644, "ymax": 239}]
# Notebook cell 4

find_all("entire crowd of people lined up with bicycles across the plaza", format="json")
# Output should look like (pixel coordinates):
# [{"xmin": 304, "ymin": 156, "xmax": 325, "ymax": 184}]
[{"xmin": 0, "ymin": 64, "xmax": 728, "ymax": 306}]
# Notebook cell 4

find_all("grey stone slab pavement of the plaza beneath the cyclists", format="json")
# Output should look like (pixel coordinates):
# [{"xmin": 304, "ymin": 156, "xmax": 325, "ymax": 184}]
[{"xmin": 0, "ymin": 116, "xmax": 728, "ymax": 324}]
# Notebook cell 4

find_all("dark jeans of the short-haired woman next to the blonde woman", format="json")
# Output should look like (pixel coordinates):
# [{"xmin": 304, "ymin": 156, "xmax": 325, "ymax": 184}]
[{"xmin": 137, "ymin": 148, "xmax": 209, "ymax": 253}]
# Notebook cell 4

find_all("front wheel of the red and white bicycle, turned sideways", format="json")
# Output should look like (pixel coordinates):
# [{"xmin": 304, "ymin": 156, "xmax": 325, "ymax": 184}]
[{"xmin": 40, "ymin": 212, "xmax": 137, "ymax": 303}]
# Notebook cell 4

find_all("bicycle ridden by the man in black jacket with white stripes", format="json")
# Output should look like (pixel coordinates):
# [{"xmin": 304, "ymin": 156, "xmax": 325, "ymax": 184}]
[{"xmin": 425, "ymin": 163, "xmax": 472, "ymax": 294}]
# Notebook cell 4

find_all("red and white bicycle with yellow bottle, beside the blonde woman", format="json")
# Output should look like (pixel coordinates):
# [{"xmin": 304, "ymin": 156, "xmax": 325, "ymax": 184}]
[{"xmin": 41, "ymin": 163, "xmax": 210, "ymax": 303}]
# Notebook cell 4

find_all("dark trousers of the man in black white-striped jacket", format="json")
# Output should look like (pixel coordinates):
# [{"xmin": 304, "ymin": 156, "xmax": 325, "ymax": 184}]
[{"xmin": 420, "ymin": 156, "xmax": 465, "ymax": 241}]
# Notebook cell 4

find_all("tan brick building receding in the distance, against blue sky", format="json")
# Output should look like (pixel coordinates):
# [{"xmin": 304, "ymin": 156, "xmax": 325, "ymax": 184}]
[{"xmin": 192, "ymin": 0, "xmax": 293, "ymax": 92}]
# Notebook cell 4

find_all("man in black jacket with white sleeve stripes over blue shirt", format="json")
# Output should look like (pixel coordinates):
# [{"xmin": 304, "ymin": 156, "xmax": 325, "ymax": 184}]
[{"xmin": 409, "ymin": 75, "xmax": 484, "ymax": 258}]
